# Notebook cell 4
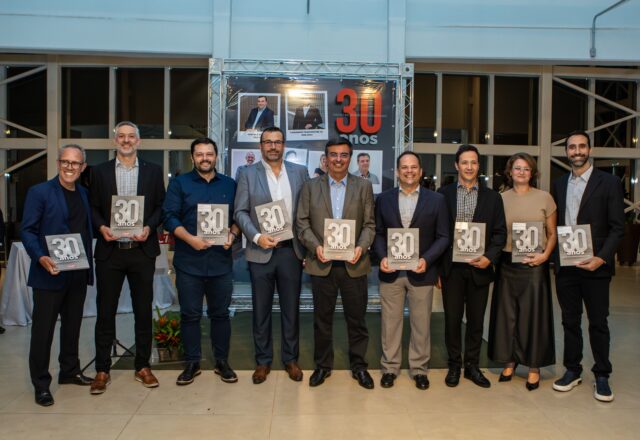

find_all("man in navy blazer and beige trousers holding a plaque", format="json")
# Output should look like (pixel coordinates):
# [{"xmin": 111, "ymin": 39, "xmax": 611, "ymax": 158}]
[{"xmin": 373, "ymin": 151, "xmax": 449, "ymax": 390}]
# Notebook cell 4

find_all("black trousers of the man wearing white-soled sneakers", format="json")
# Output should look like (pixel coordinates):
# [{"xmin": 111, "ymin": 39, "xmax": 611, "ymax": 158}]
[{"xmin": 556, "ymin": 267, "xmax": 612, "ymax": 377}]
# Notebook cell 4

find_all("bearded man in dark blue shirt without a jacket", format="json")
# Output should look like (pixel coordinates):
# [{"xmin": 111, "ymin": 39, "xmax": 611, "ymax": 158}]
[{"xmin": 163, "ymin": 138, "xmax": 240, "ymax": 385}]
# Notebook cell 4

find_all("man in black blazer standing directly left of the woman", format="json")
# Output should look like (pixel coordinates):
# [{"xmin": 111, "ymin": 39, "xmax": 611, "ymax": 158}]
[{"xmin": 439, "ymin": 145, "xmax": 507, "ymax": 388}]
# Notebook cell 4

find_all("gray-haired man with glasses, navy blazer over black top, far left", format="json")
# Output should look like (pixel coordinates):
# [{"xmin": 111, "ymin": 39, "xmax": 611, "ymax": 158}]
[{"xmin": 22, "ymin": 145, "xmax": 93, "ymax": 406}]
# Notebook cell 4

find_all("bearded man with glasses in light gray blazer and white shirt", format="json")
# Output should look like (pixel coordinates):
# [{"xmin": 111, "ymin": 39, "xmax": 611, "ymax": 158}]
[{"xmin": 234, "ymin": 127, "xmax": 309, "ymax": 384}]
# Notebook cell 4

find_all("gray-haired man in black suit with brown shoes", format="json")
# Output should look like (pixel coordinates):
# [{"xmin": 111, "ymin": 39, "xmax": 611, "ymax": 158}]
[{"xmin": 90, "ymin": 121, "xmax": 165, "ymax": 394}]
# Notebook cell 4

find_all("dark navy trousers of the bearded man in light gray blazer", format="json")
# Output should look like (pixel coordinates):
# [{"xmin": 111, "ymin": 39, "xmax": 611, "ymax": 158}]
[{"xmin": 249, "ymin": 247, "xmax": 302, "ymax": 365}]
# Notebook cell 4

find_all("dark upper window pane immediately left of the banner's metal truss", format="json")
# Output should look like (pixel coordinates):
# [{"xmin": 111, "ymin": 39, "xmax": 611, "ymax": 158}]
[{"xmin": 170, "ymin": 69, "xmax": 209, "ymax": 139}]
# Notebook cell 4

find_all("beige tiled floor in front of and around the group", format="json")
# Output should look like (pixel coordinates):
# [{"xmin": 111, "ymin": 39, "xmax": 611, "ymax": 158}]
[{"xmin": 0, "ymin": 265, "xmax": 640, "ymax": 440}]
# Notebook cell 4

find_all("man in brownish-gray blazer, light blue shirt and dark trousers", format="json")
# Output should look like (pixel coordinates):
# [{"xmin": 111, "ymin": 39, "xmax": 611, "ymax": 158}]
[{"xmin": 296, "ymin": 138, "xmax": 375, "ymax": 389}]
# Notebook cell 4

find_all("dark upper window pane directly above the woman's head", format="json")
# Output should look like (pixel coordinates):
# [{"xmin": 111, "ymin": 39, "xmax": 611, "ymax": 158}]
[{"xmin": 493, "ymin": 76, "xmax": 538, "ymax": 145}]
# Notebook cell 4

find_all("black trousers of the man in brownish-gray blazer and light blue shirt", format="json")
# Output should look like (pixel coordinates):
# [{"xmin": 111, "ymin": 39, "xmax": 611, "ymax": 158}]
[{"xmin": 311, "ymin": 262, "xmax": 369, "ymax": 371}]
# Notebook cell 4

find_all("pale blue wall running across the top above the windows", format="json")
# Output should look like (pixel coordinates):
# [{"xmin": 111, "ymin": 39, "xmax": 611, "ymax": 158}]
[{"xmin": 0, "ymin": 0, "xmax": 640, "ymax": 64}]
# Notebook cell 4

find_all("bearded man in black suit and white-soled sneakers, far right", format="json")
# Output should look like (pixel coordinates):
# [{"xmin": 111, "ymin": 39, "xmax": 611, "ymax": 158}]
[{"xmin": 551, "ymin": 131, "xmax": 624, "ymax": 402}]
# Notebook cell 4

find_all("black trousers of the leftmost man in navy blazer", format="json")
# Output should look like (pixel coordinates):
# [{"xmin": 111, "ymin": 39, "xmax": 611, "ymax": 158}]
[{"xmin": 29, "ymin": 270, "xmax": 87, "ymax": 391}]
